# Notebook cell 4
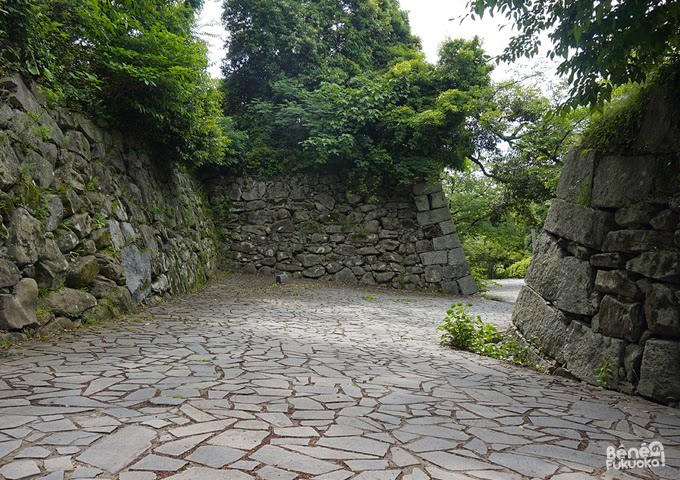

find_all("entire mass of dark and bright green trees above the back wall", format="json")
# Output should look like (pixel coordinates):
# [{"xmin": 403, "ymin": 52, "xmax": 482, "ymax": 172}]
[{"xmin": 223, "ymin": 0, "xmax": 491, "ymax": 183}]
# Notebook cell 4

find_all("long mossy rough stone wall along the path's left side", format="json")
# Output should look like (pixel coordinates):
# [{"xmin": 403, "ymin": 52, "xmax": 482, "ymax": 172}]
[{"xmin": 0, "ymin": 77, "xmax": 216, "ymax": 337}]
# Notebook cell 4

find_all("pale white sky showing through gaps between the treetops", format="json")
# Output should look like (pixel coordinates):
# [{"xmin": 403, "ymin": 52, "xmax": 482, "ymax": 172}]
[{"xmin": 199, "ymin": 0, "xmax": 554, "ymax": 81}]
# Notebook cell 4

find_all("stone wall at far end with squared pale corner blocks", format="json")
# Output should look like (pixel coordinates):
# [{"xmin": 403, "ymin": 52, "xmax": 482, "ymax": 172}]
[{"xmin": 208, "ymin": 174, "xmax": 477, "ymax": 295}]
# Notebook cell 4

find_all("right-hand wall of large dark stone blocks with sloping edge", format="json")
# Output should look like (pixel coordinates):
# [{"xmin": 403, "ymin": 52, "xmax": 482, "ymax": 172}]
[{"xmin": 513, "ymin": 87, "xmax": 680, "ymax": 404}]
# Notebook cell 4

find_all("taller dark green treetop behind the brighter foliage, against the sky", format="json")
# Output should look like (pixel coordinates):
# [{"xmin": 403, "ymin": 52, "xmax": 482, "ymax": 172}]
[{"xmin": 223, "ymin": 0, "xmax": 419, "ymax": 111}]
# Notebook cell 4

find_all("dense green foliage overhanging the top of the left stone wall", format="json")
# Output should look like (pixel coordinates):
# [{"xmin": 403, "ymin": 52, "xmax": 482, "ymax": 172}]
[{"xmin": 0, "ymin": 0, "xmax": 230, "ymax": 165}]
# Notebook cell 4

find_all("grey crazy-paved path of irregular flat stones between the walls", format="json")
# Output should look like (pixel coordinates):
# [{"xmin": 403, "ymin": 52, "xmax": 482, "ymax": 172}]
[{"xmin": 0, "ymin": 275, "xmax": 680, "ymax": 480}]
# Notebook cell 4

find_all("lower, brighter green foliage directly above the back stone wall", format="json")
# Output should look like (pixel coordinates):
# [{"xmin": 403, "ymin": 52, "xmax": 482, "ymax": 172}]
[{"xmin": 226, "ymin": 23, "xmax": 491, "ymax": 187}]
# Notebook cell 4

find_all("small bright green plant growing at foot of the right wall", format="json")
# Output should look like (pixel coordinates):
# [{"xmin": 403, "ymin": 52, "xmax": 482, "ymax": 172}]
[{"xmin": 439, "ymin": 302, "xmax": 531, "ymax": 365}]
